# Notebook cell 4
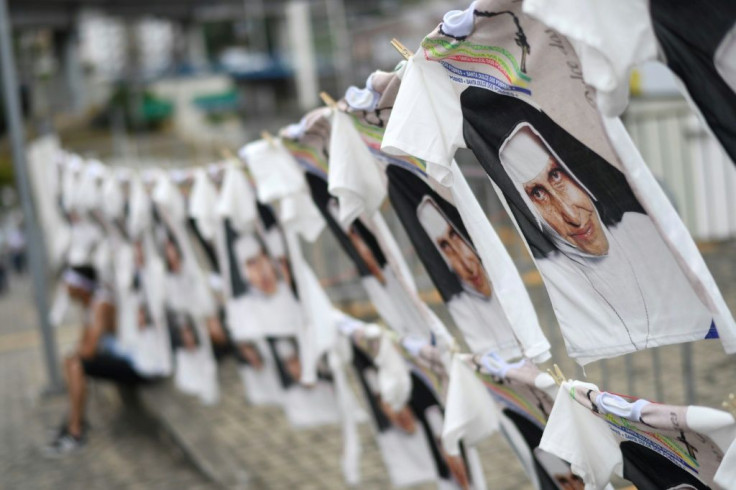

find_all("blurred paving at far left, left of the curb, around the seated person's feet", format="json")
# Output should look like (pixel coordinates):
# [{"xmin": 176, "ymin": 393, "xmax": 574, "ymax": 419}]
[{"xmin": 0, "ymin": 278, "xmax": 217, "ymax": 490}]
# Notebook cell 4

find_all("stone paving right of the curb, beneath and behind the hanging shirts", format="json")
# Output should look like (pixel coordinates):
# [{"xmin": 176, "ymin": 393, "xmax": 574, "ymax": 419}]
[{"xmin": 143, "ymin": 241, "xmax": 736, "ymax": 490}]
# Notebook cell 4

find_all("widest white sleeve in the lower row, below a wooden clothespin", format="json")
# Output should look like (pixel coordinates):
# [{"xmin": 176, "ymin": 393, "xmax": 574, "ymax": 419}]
[{"xmin": 539, "ymin": 381, "xmax": 623, "ymax": 490}]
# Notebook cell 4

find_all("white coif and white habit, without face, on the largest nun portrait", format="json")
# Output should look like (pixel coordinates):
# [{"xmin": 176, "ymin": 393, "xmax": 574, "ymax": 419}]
[{"xmin": 499, "ymin": 122, "xmax": 712, "ymax": 365}]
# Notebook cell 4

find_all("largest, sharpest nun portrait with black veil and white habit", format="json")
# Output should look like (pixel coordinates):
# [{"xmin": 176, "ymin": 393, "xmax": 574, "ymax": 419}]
[{"xmin": 463, "ymin": 89, "xmax": 715, "ymax": 364}]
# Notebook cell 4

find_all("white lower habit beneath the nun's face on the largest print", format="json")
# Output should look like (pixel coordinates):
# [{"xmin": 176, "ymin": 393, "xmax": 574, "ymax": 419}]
[{"xmin": 537, "ymin": 213, "xmax": 720, "ymax": 365}]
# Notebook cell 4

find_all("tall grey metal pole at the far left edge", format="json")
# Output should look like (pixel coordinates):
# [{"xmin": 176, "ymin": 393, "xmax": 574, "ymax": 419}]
[{"xmin": 0, "ymin": 0, "xmax": 63, "ymax": 392}]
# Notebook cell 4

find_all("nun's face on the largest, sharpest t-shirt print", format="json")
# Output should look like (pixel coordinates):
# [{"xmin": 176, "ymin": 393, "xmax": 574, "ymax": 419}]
[{"xmin": 524, "ymin": 155, "xmax": 608, "ymax": 255}]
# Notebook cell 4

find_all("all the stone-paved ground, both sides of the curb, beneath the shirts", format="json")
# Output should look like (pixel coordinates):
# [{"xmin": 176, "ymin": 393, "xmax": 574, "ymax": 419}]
[{"xmin": 0, "ymin": 241, "xmax": 736, "ymax": 490}]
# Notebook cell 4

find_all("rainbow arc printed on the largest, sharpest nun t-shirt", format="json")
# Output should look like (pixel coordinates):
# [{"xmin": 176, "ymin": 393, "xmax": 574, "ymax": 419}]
[{"xmin": 422, "ymin": 38, "xmax": 531, "ymax": 96}]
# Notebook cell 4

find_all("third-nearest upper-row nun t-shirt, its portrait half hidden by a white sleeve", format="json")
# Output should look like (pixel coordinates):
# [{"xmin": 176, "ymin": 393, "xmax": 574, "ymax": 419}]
[{"xmin": 282, "ymin": 108, "xmax": 447, "ymax": 344}]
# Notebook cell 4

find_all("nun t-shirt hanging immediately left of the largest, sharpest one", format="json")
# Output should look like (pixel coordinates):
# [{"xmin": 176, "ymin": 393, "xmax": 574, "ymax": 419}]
[{"xmin": 336, "ymin": 72, "xmax": 549, "ymax": 361}]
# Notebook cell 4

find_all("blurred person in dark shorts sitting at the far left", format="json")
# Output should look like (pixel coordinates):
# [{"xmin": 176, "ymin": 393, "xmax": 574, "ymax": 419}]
[{"xmin": 46, "ymin": 266, "xmax": 152, "ymax": 456}]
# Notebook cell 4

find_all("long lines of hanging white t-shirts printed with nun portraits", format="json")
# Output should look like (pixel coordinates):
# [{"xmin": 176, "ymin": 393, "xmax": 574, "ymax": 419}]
[{"xmin": 31, "ymin": 0, "xmax": 736, "ymax": 489}]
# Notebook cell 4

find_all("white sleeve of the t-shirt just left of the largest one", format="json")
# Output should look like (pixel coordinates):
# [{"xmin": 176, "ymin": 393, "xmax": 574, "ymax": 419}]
[{"xmin": 328, "ymin": 110, "xmax": 386, "ymax": 226}]
